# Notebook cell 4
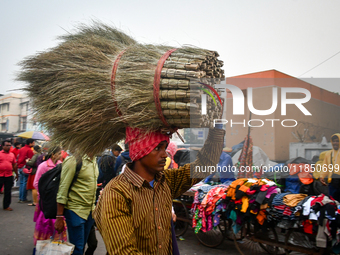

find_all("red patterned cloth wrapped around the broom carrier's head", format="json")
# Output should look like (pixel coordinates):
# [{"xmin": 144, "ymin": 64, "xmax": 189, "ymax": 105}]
[{"xmin": 125, "ymin": 127, "xmax": 170, "ymax": 161}]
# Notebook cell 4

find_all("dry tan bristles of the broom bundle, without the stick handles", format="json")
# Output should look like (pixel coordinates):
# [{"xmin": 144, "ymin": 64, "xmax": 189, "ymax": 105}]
[{"xmin": 17, "ymin": 22, "xmax": 224, "ymax": 155}]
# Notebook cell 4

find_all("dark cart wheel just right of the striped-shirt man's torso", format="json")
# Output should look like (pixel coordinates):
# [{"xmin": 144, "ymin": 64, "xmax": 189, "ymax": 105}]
[{"xmin": 172, "ymin": 199, "xmax": 189, "ymax": 237}]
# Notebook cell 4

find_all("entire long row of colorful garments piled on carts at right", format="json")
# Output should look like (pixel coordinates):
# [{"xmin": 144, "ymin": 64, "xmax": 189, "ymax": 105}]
[{"xmin": 192, "ymin": 178, "xmax": 340, "ymax": 251}]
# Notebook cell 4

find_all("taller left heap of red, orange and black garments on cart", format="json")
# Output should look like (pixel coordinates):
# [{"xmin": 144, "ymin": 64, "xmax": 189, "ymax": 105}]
[{"xmin": 192, "ymin": 178, "xmax": 280, "ymax": 233}]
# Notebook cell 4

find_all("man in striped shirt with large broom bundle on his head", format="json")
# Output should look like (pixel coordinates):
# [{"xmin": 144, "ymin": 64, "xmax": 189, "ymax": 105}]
[{"xmin": 17, "ymin": 22, "xmax": 224, "ymax": 255}]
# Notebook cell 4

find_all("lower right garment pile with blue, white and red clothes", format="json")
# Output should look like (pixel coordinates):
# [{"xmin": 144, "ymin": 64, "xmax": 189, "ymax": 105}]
[{"xmin": 258, "ymin": 193, "xmax": 340, "ymax": 249}]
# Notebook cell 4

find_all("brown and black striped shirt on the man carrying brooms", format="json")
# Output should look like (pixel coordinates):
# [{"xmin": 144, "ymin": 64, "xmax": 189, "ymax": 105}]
[{"xmin": 94, "ymin": 129, "xmax": 224, "ymax": 255}]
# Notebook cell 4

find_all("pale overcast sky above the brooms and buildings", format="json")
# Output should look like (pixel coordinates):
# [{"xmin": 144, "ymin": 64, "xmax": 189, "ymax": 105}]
[{"xmin": 0, "ymin": 0, "xmax": 340, "ymax": 94}]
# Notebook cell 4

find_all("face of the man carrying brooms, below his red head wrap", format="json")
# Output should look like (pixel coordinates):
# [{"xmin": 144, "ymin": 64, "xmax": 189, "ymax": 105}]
[{"xmin": 140, "ymin": 141, "xmax": 168, "ymax": 174}]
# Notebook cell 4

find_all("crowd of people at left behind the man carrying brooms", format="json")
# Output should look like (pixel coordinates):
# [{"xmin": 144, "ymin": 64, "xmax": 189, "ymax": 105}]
[{"xmin": 0, "ymin": 139, "xmax": 125, "ymax": 255}]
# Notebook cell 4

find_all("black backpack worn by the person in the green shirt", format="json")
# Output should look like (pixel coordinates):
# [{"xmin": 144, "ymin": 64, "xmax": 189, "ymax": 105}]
[{"xmin": 38, "ymin": 161, "xmax": 82, "ymax": 219}]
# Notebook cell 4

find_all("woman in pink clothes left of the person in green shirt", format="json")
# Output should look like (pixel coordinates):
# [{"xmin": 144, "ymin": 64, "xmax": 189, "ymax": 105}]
[{"xmin": 33, "ymin": 147, "xmax": 67, "ymax": 245}]
